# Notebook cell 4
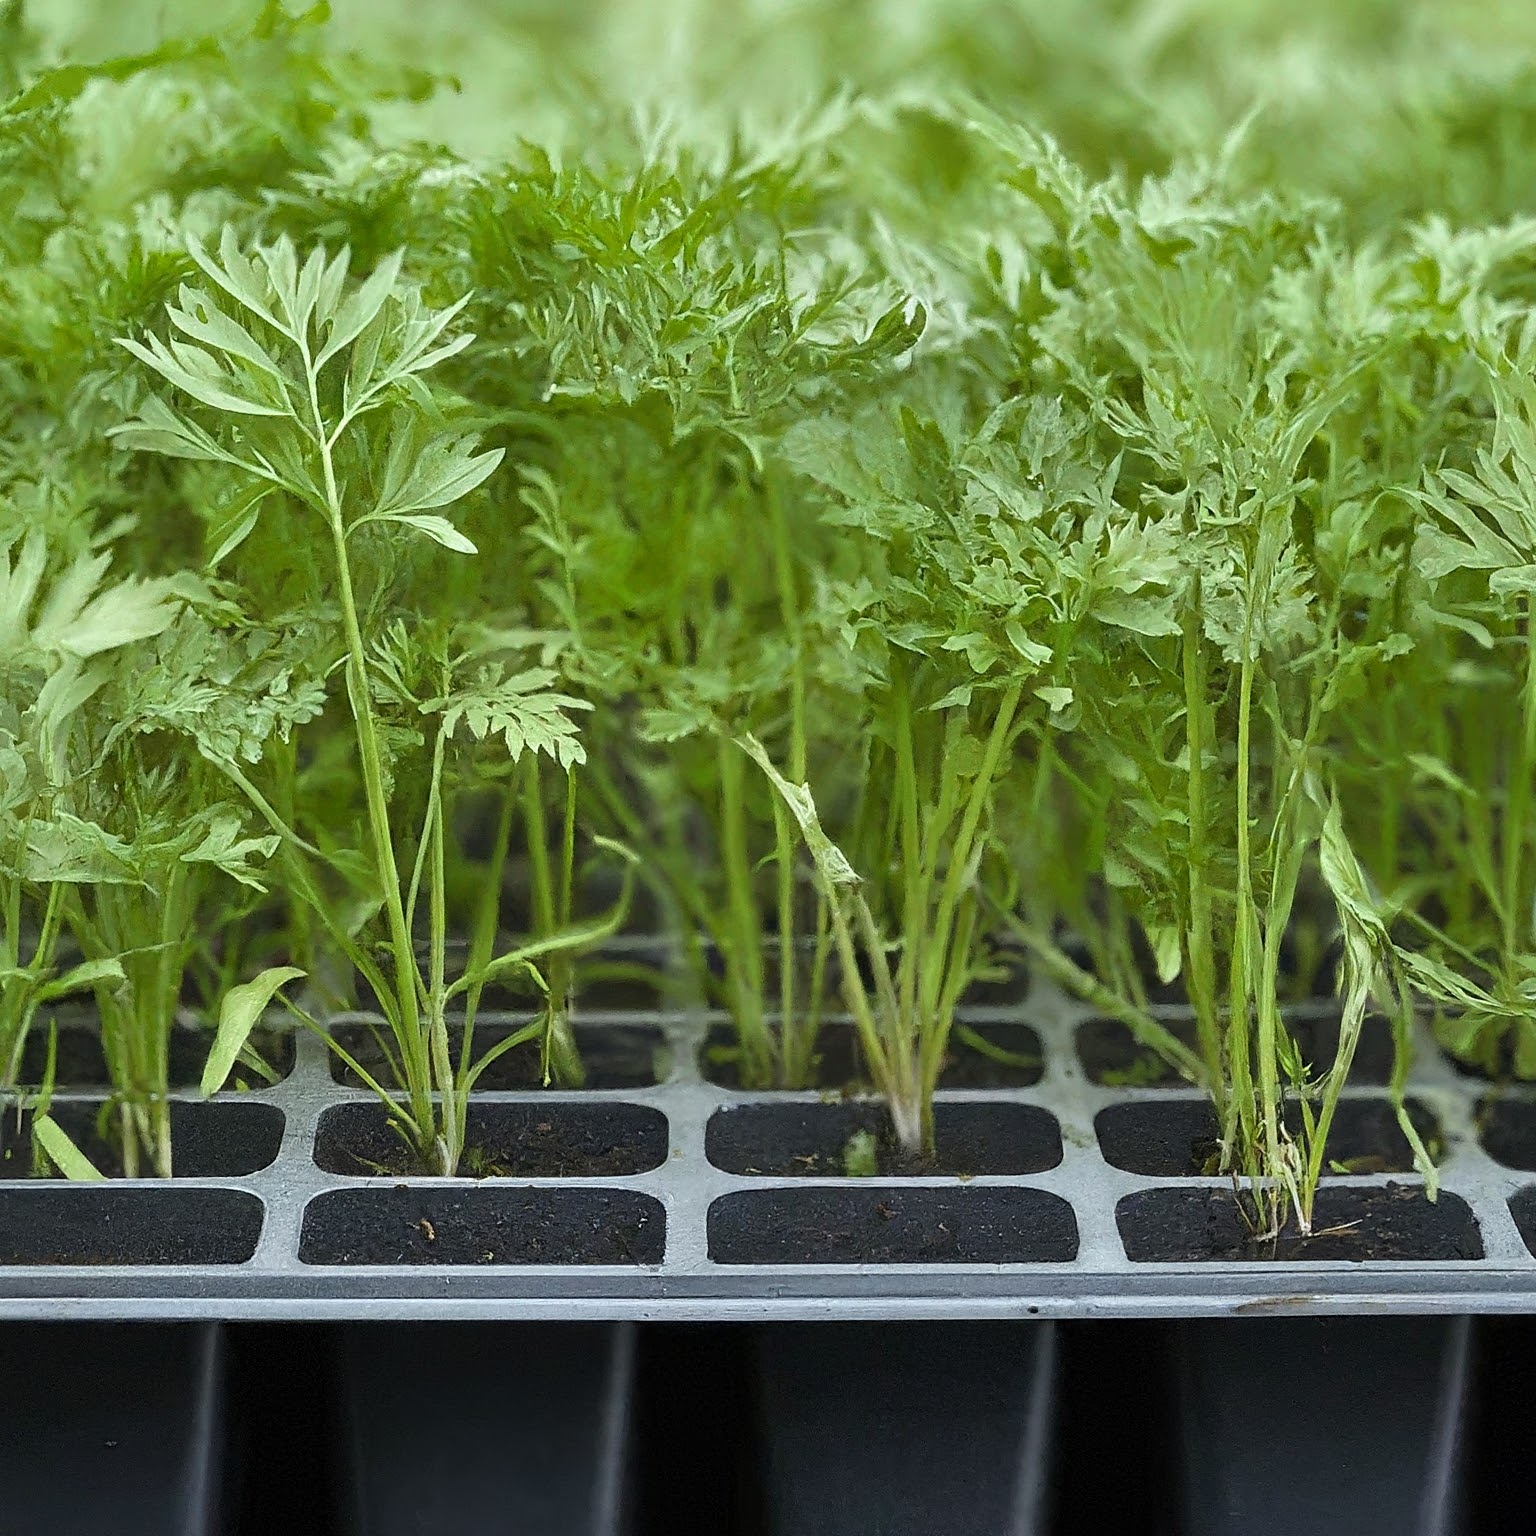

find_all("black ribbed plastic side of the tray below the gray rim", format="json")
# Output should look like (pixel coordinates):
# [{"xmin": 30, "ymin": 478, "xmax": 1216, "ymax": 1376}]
[{"xmin": 0, "ymin": 1316, "xmax": 1480, "ymax": 1536}]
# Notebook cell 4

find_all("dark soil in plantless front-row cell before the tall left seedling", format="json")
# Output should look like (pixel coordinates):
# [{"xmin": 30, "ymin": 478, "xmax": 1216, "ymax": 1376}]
[{"xmin": 298, "ymin": 1184, "xmax": 667, "ymax": 1264}]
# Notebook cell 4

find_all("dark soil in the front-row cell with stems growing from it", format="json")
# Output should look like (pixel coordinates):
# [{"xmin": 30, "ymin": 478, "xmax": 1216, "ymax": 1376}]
[{"xmin": 1115, "ymin": 1184, "xmax": 1482, "ymax": 1264}]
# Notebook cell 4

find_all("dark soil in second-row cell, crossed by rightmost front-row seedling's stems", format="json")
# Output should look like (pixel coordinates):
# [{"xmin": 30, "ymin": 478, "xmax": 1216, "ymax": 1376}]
[{"xmin": 1094, "ymin": 1098, "xmax": 1437, "ymax": 1178}]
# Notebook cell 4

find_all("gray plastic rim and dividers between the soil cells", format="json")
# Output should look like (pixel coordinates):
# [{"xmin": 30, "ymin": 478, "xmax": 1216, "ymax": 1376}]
[{"xmin": 0, "ymin": 983, "xmax": 1536, "ymax": 1321}]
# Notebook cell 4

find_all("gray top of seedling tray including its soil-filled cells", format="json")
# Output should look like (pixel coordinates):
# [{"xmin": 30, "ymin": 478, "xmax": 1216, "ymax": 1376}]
[{"xmin": 0, "ymin": 958, "xmax": 1536, "ymax": 1321}]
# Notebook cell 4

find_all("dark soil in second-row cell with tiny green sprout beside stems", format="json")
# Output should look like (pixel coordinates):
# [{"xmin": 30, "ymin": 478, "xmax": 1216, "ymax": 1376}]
[{"xmin": 703, "ymin": 1098, "xmax": 1061, "ymax": 1178}]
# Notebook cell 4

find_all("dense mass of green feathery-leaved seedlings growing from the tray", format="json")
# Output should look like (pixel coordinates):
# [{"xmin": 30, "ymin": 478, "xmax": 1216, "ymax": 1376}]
[{"xmin": 0, "ymin": 5, "xmax": 1536, "ymax": 1230}]
